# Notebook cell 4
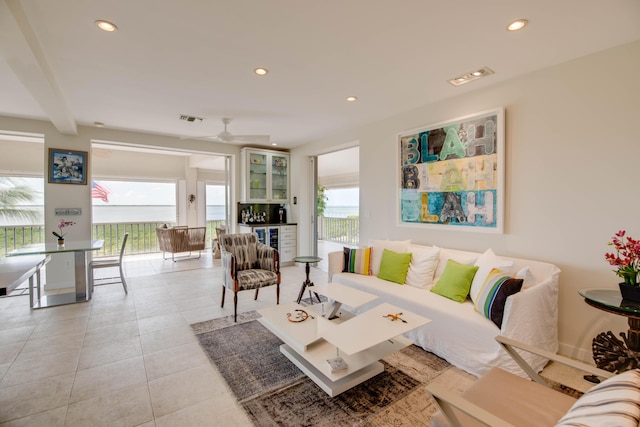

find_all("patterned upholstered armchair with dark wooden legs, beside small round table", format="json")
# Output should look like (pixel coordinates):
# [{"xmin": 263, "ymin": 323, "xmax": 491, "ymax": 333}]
[{"xmin": 220, "ymin": 233, "xmax": 280, "ymax": 322}]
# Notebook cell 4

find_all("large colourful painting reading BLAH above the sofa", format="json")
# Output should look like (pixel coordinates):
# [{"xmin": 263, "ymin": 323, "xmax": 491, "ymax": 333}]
[{"xmin": 397, "ymin": 108, "xmax": 504, "ymax": 233}]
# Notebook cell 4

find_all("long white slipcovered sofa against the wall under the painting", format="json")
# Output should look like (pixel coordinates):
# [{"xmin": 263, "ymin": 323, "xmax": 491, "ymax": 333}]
[{"xmin": 328, "ymin": 240, "xmax": 560, "ymax": 376}]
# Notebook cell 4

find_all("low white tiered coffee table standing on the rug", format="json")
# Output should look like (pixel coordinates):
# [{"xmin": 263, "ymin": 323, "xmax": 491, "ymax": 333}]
[{"xmin": 258, "ymin": 284, "xmax": 430, "ymax": 397}]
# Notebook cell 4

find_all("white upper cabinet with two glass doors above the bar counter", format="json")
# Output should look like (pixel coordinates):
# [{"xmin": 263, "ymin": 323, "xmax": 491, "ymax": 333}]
[{"xmin": 241, "ymin": 148, "xmax": 289, "ymax": 203}]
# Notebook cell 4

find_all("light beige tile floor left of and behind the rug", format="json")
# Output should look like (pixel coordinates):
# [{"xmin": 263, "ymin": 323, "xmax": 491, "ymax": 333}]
[{"xmin": 0, "ymin": 253, "xmax": 326, "ymax": 427}]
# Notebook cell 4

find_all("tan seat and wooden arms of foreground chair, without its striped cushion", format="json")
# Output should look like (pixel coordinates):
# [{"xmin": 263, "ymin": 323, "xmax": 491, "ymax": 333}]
[{"xmin": 427, "ymin": 336, "xmax": 615, "ymax": 427}]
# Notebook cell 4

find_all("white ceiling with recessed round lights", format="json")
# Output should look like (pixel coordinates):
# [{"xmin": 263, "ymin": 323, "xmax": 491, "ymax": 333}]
[{"xmin": 0, "ymin": 0, "xmax": 640, "ymax": 152}]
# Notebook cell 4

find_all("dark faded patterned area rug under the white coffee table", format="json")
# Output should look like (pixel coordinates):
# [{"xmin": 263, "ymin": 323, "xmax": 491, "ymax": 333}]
[{"xmin": 192, "ymin": 312, "xmax": 450, "ymax": 426}]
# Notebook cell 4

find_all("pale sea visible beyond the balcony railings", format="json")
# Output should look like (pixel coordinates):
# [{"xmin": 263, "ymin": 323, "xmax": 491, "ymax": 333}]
[{"xmin": 0, "ymin": 205, "xmax": 359, "ymax": 226}]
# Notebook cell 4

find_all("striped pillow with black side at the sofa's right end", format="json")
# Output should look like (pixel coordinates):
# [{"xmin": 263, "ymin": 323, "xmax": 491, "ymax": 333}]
[{"xmin": 474, "ymin": 268, "xmax": 523, "ymax": 328}]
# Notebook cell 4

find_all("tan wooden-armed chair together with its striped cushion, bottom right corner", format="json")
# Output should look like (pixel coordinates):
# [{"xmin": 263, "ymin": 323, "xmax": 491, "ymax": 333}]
[{"xmin": 427, "ymin": 336, "xmax": 640, "ymax": 427}]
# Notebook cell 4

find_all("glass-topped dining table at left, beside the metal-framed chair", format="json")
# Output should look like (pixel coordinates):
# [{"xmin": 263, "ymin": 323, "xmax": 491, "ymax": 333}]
[{"xmin": 7, "ymin": 240, "xmax": 104, "ymax": 308}]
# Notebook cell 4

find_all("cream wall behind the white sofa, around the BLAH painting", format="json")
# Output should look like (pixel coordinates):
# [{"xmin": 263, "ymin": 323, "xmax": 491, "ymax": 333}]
[{"xmin": 292, "ymin": 41, "xmax": 640, "ymax": 360}]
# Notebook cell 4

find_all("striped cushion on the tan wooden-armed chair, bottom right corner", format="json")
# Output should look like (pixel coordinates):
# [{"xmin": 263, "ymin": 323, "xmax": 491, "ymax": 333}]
[{"xmin": 556, "ymin": 369, "xmax": 640, "ymax": 427}]
